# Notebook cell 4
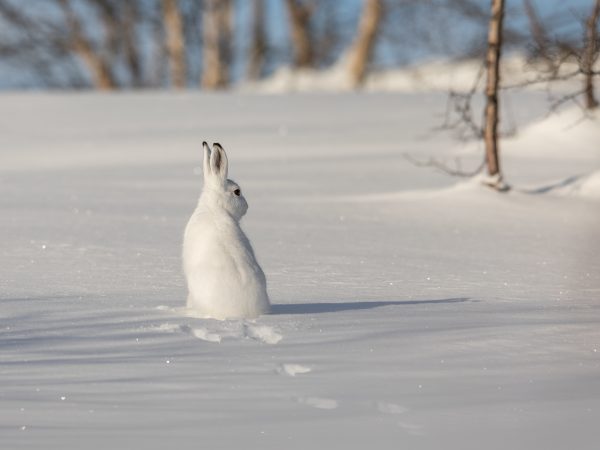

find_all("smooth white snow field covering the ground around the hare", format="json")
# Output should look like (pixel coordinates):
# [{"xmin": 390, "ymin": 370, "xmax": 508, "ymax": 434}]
[{"xmin": 0, "ymin": 92, "xmax": 600, "ymax": 449}]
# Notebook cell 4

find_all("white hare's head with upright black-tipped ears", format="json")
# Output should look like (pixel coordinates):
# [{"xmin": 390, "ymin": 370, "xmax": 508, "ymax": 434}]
[{"xmin": 202, "ymin": 142, "xmax": 248, "ymax": 220}]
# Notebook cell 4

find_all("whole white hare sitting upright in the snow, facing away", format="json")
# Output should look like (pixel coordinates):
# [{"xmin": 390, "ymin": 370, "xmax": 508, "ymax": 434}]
[{"xmin": 183, "ymin": 142, "xmax": 270, "ymax": 320}]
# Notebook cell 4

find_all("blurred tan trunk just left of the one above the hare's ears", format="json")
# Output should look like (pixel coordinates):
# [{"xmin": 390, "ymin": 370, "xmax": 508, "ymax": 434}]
[{"xmin": 162, "ymin": 0, "xmax": 187, "ymax": 89}]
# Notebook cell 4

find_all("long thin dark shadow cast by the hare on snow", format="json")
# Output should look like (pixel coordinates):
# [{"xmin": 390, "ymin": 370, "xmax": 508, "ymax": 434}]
[{"xmin": 271, "ymin": 297, "xmax": 473, "ymax": 315}]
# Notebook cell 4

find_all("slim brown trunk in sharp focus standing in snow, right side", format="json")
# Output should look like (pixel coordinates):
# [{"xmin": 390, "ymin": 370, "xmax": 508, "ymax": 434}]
[{"xmin": 484, "ymin": 0, "xmax": 504, "ymax": 188}]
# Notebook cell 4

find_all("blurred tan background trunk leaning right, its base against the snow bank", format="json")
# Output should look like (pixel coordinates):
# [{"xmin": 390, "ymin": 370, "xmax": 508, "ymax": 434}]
[{"xmin": 350, "ymin": 0, "xmax": 383, "ymax": 87}]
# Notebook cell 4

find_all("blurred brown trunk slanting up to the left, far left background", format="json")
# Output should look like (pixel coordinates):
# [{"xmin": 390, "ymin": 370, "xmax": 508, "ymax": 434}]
[{"xmin": 59, "ymin": 0, "xmax": 117, "ymax": 90}]
